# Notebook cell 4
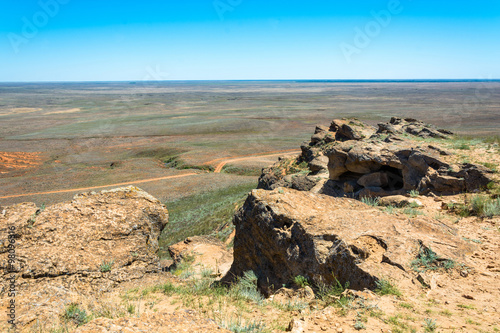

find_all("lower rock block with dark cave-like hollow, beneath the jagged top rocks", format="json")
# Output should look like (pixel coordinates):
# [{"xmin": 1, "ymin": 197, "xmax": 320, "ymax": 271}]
[{"xmin": 326, "ymin": 141, "xmax": 492, "ymax": 196}]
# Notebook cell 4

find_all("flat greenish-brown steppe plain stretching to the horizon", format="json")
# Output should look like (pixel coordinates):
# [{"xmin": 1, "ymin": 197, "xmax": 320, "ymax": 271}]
[{"xmin": 0, "ymin": 81, "xmax": 500, "ymax": 205}]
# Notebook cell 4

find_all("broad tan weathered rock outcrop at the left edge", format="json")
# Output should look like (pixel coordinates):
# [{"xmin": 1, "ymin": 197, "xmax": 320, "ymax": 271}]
[{"xmin": 0, "ymin": 187, "xmax": 168, "ymax": 326}]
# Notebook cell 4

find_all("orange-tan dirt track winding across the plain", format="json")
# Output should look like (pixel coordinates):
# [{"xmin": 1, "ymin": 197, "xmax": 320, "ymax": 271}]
[{"xmin": 0, "ymin": 150, "xmax": 300, "ymax": 199}]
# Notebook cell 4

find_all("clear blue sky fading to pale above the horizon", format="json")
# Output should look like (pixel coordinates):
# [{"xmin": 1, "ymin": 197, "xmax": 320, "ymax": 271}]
[{"xmin": 0, "ymin": 0, "xmax": 500, "ymax": 81}]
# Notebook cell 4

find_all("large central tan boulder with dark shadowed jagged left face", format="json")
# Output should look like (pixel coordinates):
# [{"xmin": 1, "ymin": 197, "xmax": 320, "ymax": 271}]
[{"xmin": 223, "ymin": 188, "xmax": 473, "ymax": 291}]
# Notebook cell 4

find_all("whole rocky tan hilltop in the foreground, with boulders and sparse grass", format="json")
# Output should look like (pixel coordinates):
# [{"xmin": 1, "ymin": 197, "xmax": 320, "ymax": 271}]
[{"xmin": 0, "ymin": 117, "xmax": 500, "ymax": 332}]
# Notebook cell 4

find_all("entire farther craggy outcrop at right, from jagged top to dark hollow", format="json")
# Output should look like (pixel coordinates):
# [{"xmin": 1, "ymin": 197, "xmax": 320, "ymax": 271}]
[{"xmin": 259, "ymin": 117, "xmax": 492, "ymax": 198}]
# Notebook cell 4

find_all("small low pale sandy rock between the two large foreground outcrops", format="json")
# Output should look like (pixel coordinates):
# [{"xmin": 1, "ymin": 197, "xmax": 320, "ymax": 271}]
[{"xmin": 168, "ymin": 236, "xmax": 233, "ymax": 276}]
